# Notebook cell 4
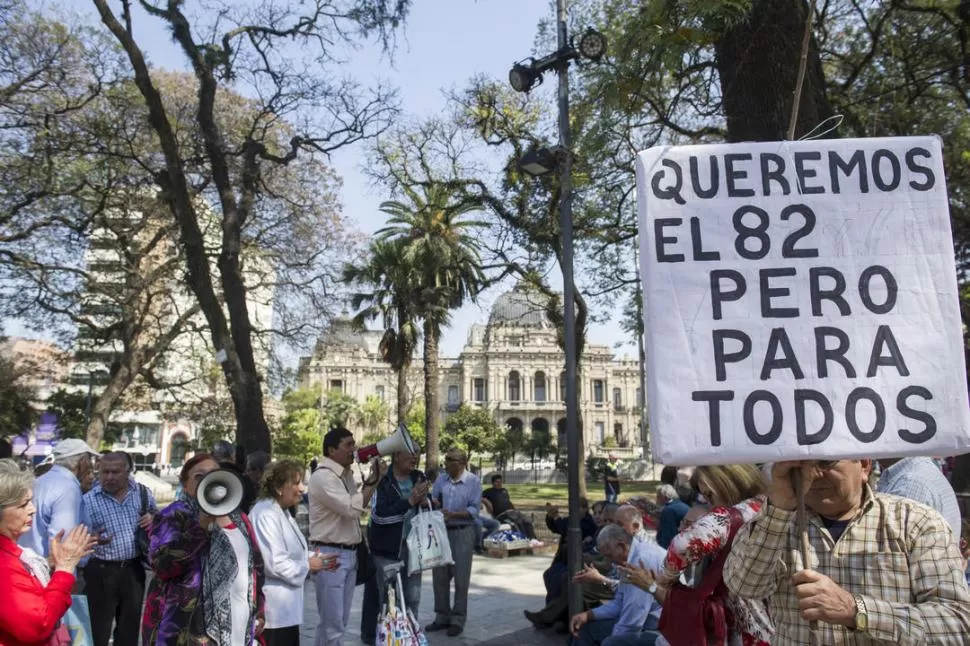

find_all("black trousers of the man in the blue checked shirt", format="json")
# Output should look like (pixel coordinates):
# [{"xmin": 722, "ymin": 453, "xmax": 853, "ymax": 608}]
[{"xmin": 84, "ymin": 559, "xmax": 145, "ymax": 646}]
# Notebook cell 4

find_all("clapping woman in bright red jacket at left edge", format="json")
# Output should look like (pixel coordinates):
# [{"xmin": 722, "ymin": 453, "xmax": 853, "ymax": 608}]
[{"xmin": 0, "ymin": 460, "xmax": 97, "ymax": 646}]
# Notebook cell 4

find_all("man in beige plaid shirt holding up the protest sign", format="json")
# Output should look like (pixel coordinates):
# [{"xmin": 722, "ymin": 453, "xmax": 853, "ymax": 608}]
[{"xmin": 724, "ymin": 460, "xmax": 970, "ymax": 646}]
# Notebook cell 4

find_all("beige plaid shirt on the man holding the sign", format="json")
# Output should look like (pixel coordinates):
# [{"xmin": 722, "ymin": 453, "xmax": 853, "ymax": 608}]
[{"xmin": 724, "ymin": 487, "xmax": 970, "ymax": 646}]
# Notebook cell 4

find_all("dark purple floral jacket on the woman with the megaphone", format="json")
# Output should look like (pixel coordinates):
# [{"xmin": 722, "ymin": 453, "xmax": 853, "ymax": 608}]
[{"xmin": 141, "ymin": 501, "xmax": 264, "ymax": 646}]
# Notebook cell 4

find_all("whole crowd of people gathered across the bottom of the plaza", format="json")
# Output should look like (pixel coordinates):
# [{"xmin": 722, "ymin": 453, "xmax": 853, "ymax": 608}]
[{"xmin": 0, "ymin": 428, "xmax": 970, "ymax": 646}]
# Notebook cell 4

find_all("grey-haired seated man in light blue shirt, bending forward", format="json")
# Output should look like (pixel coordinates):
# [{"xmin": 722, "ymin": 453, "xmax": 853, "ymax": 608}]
[{"xmin": 569, "ymin": 525, "xmax": 666, "ymax": 646}]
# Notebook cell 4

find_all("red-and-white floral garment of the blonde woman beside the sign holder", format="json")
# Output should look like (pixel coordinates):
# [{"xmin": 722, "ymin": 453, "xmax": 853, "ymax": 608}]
[{"xmin": 657, "ymin": 496, "xmax": 774, "ymax": 646}]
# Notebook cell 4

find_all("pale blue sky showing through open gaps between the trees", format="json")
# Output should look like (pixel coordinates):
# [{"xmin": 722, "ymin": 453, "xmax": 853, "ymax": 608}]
[{"xmin": 4, "ymin": 0, "xmax": 635, "ymax": 364}]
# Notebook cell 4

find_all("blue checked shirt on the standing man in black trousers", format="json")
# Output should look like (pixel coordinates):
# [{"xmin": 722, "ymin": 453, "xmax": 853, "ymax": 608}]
[{"xmin": 84, "ymin": 478, "xmax": 158, "ymax": 561}]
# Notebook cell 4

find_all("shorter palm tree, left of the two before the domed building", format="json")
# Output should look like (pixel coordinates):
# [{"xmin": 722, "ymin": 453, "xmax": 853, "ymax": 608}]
[{"xmin": 343, "ymin": 240, "xmax": 418, "ymax": 422}]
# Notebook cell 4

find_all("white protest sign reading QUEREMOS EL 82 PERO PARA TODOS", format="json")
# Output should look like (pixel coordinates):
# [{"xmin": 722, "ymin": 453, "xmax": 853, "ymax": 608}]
[{"xmin": 637, "ymin": 137, "xmax": 970, "ymax": 464}]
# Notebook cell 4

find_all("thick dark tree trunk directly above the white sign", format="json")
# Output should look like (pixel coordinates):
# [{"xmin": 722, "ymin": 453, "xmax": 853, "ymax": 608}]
[{"xmin": 715, "ymin": 0, "xmax": 832, "ymax": 142}]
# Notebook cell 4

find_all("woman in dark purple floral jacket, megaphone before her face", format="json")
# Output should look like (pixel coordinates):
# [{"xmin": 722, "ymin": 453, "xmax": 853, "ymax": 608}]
[{"xmin": 142, "ymin": 453, "xmax": 265, "ymax": 646}]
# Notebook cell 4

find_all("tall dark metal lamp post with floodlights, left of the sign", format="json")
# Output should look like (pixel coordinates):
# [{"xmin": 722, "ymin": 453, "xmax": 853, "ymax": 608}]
[{"xmin": 509, "ymin": 0, "xmax": 606, "ymax": 616}]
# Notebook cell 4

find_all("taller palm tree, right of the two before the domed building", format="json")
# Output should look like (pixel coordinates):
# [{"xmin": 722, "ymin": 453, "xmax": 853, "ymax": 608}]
[{"xmin": 377, "ymin": 184, "xmax": 485, "ymax": 468}]
